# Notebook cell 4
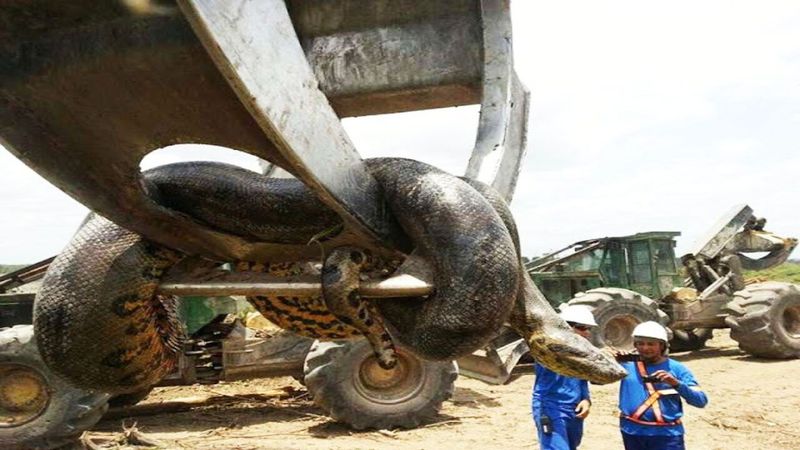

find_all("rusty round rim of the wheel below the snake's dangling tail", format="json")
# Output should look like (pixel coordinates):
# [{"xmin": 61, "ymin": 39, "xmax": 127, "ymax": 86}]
[{"xmin": 354, "ymin": 352, "xmax": 425, "ymax": 405}]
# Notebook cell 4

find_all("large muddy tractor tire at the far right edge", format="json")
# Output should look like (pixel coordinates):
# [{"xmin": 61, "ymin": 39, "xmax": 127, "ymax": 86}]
[{"xmin": 725, "ymin": 281, "xmax": 800, "ymax": 359}]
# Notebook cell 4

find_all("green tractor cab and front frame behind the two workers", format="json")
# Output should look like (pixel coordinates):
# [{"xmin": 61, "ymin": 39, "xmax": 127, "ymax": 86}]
[{"xmin": 525, "ymin": 231, "xmax": 682, "ymax": 306}]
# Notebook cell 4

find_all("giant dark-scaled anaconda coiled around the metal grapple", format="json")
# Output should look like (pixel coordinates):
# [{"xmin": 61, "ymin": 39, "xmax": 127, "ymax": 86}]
[{"xmin": 34, "ymin": 158, "xmax": 624, "ymax": 393}]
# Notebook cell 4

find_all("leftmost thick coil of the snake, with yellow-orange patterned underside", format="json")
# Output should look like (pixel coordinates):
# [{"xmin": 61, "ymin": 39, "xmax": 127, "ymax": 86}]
[{"xmin": 34, "ymin": 214, "xmax": 182, "ymax": 393}]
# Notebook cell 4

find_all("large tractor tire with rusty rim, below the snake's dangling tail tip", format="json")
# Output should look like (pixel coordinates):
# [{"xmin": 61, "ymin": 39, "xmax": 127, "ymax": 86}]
[{"xmin": 304, "ymin": 340, "xmax": 458, "ymax": 430}]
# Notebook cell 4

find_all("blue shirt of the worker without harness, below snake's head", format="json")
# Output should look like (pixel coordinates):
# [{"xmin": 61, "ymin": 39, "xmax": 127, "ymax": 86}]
[{"xmin": 533, "ymin": 363, "xmax": 590, "ymax": 419}]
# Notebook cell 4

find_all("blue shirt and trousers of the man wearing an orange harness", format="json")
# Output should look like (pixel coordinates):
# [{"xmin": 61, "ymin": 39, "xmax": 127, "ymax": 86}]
[{"xmin": 619, "ymin": 358, "xmax": 708, "ymax": 450}]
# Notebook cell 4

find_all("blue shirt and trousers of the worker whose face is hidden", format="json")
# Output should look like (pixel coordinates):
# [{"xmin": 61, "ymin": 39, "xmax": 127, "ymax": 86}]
[{"xmin": 531, "ymin": 364, "xmax": 591, "ymax": 450}]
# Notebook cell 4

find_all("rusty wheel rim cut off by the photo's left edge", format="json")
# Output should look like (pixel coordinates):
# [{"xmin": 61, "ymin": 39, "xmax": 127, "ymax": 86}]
[{"xmin": 0, "ymin": 364, "xmax": 50, "ymax": 428}]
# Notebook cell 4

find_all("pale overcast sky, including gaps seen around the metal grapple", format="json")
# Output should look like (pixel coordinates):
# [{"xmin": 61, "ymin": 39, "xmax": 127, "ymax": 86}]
[{"xmin": 0, "ymin": 0, "xmax": 800, "ymax": 264}]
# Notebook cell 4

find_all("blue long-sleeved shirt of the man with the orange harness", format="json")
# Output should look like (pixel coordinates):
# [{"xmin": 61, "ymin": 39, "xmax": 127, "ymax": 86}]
[{"xmin": 619, "ymin": 358, "xmax": 708, "ymax": 436}]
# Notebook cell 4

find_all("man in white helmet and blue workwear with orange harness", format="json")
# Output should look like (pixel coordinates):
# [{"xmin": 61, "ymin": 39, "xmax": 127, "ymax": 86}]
[{"xmin": 616, "ymin": 322, "xmax": 708, "ymax": 450}]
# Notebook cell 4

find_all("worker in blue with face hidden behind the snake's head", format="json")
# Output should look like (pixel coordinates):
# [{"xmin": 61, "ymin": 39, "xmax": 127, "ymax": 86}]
[{"xmin": 532, "ymin": 305, "xmax": 597, "ymax": 450}]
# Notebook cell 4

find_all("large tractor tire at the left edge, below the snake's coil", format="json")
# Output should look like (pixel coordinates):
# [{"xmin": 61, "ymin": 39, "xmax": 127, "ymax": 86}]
[{"xmin": 0, "ymin": 325, "xmax": 109, "ymax": 449}]
